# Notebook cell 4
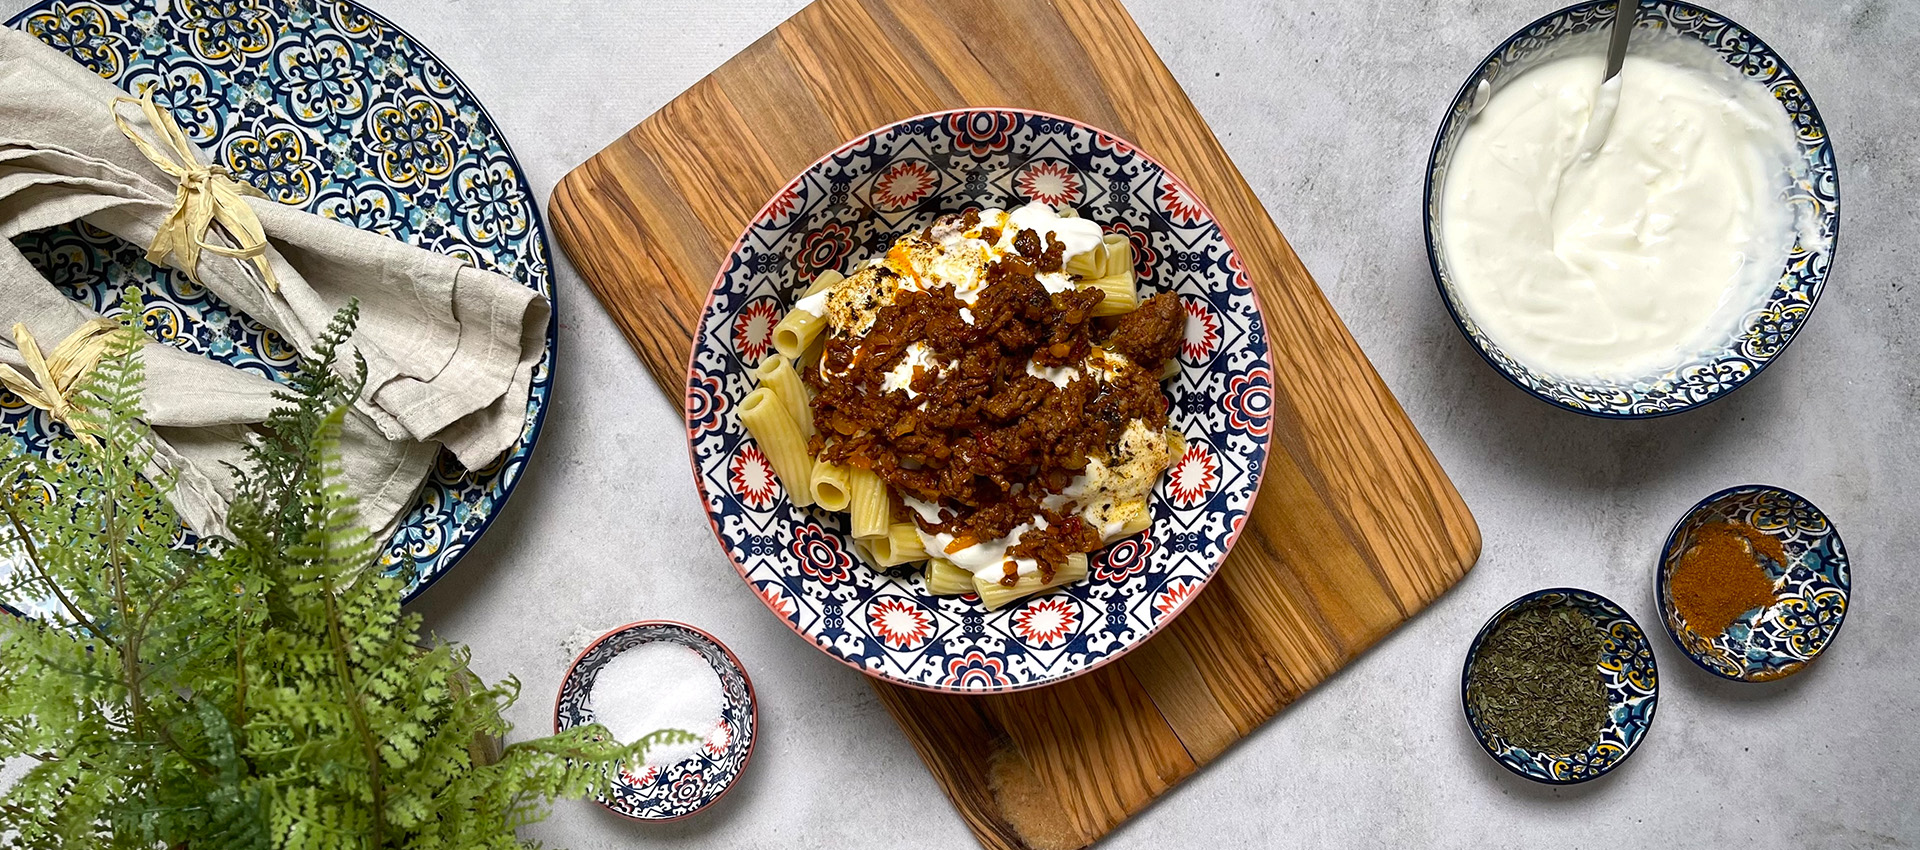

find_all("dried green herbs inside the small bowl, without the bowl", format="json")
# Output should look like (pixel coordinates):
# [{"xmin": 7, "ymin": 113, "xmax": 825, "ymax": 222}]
[{"xmin": 1467, "ymin": 602, "xmax": 1607, "ymax": 754}]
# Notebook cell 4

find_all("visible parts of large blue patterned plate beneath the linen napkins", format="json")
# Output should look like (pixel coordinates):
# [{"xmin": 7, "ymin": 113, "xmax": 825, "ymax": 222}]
[{"xmin": 0, "ymin": 0, "xmax": 559, "ymax": 614}]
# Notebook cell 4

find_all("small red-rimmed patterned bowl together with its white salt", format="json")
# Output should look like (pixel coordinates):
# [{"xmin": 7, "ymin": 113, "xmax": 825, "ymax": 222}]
[{"xmin": 553, "ymin": 620, "xmax": 760, "ymax": 821}]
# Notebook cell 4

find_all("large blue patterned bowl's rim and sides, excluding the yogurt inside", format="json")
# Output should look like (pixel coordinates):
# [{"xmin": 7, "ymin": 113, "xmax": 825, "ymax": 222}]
[{"xmin": 1423, "ymin": 0, "xmax": 1839, "ymax": 418}]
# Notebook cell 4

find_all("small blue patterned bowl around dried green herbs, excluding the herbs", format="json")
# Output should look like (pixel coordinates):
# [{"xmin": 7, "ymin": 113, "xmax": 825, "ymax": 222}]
[{"xmin": 1459, "ymin": 587, "xmax": 1661, "ymax": 785}]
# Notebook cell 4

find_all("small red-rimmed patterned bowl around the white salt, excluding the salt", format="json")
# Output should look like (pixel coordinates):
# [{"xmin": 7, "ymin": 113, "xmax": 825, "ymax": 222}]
[{"xmin": 553, "ymin": 620, "xmax": 760, "ymax": 821}]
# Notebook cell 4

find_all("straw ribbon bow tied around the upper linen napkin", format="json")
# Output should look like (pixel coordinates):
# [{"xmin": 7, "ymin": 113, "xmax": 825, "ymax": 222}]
[{"xmin": 113, "ymin": 90, "xmax": 280, "ymax": 292}]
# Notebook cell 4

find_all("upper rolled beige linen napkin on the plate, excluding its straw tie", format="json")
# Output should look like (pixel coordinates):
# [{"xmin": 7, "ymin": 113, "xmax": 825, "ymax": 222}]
[{"xmin": 0, "ymin": 29, "xmax": 549, "ymax": 475}]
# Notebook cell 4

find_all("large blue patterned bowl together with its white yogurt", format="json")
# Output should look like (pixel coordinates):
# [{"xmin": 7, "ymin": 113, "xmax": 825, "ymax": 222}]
[{"xmin": 1425, "ymin": 0, "xmax": 1839, "ymax": 418}]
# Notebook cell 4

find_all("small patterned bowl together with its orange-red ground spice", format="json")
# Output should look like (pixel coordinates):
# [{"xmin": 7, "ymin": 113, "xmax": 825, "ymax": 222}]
[{"xmin": 1653, "ymin": 484, "xmax": 1853, "ymax": 681}]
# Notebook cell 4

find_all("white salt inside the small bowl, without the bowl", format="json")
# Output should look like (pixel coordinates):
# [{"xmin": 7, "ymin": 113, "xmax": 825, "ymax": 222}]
[{"xmin": 588, "ymin": 641, "xmax": 728, "ymax": 767}]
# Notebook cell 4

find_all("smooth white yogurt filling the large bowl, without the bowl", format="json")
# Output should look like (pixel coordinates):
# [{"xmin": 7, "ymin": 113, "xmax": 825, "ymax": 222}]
[{"xmin": 1440, "ymin": 33, "xmax": 1805, "ymax": 378}]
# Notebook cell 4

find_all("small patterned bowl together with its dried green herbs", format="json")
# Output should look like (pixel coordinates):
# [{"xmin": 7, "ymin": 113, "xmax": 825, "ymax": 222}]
[{"xmin": 1461, "ymin": 587, "xmax": 1659, "ymax": 785}]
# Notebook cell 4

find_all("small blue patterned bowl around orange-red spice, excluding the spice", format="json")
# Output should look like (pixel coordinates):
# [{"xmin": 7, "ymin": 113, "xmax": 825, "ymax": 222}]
[{"xmin": 1653, "ymin": 484, "xmax": 1853, "ymax": 681}]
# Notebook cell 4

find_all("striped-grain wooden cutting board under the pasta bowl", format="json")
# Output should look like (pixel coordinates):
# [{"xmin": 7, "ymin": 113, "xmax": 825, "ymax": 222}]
[{"xmin": 549, "ymin": 0, "xmax": 1480, "ymax": 850}]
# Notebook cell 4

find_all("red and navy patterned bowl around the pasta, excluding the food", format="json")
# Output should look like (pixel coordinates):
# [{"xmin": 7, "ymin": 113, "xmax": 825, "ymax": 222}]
[{"xmin": 687, "ymin": 109, "xmax": 1273, "ymax": 693}]
